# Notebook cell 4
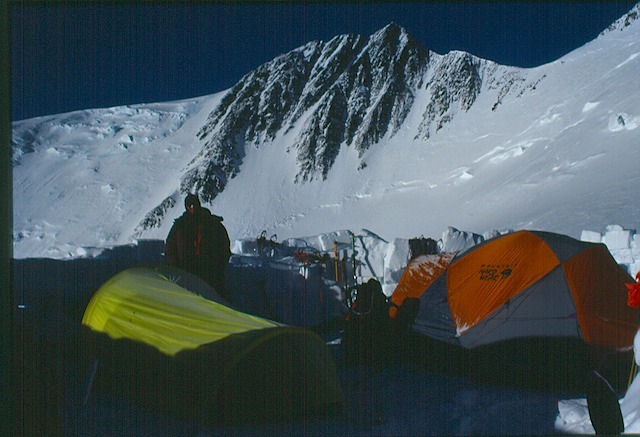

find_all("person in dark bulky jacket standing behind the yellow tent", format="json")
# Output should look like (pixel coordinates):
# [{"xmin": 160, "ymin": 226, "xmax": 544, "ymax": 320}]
[{"xmin": 165, "ymin": 194, "xmax": 231, "ymax": 302}]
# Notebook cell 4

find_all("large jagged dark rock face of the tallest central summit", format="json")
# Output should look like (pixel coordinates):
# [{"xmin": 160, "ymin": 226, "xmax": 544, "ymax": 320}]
[{"xmin": 181, "ymin": 23, "xmax": 428, "ymax": 194}]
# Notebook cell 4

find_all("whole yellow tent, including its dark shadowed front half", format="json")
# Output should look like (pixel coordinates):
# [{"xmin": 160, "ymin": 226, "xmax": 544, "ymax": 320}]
[{"xmin": 82, "ymin": 267, "xmax": 344, "ymax": 423}]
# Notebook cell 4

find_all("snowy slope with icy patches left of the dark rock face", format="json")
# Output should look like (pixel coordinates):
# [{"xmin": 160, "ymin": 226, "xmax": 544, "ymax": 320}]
[{"xmin": 13, "ymin": 96, "xmax": 225, "ymax": 258}]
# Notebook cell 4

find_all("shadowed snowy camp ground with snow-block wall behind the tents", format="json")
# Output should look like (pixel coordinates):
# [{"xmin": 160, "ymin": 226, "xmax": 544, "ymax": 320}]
[{"xmin": 14, "ymin": 223, "xmax": 635, "ymax": 436}]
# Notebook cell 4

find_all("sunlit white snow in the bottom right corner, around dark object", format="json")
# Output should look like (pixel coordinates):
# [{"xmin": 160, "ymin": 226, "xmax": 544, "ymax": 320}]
[{"xmin": 555, "ymin": 331, "xmax": 640, "ymax": 434}]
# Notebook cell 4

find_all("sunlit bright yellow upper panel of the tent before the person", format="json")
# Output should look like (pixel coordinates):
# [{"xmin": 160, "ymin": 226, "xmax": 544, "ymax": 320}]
[{"xmin": 82, "ymin": 268, "xmax": 280, "ymax": 355}]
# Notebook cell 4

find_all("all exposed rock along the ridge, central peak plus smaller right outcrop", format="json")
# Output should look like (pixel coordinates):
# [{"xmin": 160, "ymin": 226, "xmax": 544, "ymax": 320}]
[{"xmin": 164, "ymin": 23, "xmax": 525, "ymax": 220}]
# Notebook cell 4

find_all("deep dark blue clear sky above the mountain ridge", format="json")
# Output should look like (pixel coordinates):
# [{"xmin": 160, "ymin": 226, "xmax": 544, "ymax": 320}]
[{"xmin": 9, "ymin": 0, "xmax": 635, "ymax": 120}]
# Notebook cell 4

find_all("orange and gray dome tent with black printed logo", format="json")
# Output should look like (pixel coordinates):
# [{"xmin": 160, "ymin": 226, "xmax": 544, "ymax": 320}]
[{"xmin": 391, "ymin": 231, "xmax": 638, "ymax": 350}]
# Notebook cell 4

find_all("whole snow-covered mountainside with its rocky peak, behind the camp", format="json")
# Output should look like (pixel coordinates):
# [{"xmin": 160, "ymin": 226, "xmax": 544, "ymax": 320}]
[{"xmin": 13, "ymin": 6, "xmax": 640, "ymax": 258}]
